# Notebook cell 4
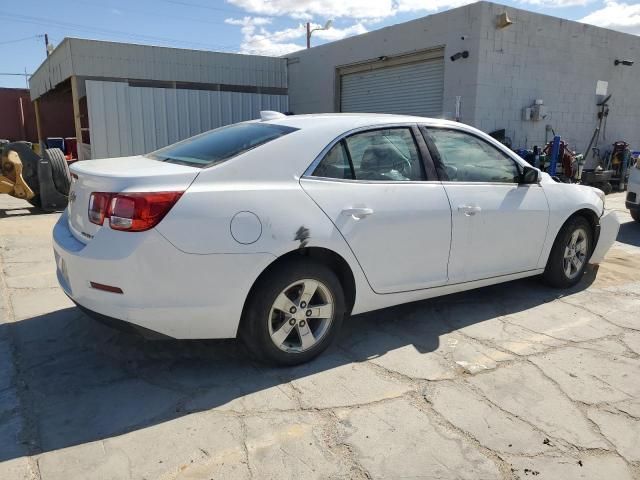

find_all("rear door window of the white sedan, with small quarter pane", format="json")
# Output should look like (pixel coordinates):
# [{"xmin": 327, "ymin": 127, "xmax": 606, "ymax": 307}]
[{"xmin": 313, "ymin": 128, "xmax": 425, "ymax": 181}]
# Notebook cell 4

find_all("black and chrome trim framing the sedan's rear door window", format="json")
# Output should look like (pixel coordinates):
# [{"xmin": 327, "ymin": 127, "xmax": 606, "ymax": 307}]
[{"xmin": 301, "ymin": 122, "xmax": 440, "ymax": 184}]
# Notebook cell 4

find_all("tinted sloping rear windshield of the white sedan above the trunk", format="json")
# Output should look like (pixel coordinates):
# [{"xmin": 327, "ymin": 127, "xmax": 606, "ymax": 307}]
[{"xmin": 147, "ymin": 123, "xmax": 297, "ymax": 167}]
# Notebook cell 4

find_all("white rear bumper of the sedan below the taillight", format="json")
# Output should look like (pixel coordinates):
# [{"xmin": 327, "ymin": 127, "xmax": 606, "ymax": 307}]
[{"xmin": 53, "ymin": 212, "xmax": 274, "ymax": 339}]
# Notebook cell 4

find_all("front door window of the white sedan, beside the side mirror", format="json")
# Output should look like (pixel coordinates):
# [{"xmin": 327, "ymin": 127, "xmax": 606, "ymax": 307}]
[{"xmin": 429, "ymin": 128, "xmax": 520, "ymax": 183}]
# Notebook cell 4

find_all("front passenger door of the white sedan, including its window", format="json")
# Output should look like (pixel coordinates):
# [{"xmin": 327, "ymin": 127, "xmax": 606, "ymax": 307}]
[{"xmin": 423, "ymin": 128, "xmax": 549, "ymax": 283}]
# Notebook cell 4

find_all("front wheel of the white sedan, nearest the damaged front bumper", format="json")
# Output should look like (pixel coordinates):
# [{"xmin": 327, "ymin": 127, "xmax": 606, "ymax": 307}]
[{"xmin": 543, "ymin": 216, "xmax": 593, "ymax": 288}]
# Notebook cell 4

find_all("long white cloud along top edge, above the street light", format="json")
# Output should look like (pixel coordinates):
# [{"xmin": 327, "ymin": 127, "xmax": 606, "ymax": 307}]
[{"xmin": 227, "ymin": 0, "xmax": 476, "ymax": 20}]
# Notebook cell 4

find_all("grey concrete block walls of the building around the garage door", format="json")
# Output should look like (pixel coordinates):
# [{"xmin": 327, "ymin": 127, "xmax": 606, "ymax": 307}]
[{"xmin": 288, "ymin": 1, "xmax": 640, "ymax": 152}]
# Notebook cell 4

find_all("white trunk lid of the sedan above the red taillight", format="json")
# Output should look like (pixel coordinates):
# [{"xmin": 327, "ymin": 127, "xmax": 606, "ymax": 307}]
[{"xmin": 67, "ymin": 156, "xmax": 201, "ymax": 243}]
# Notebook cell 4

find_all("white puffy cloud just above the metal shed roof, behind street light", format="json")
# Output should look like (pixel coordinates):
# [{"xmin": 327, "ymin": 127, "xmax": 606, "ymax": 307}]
[{"xmin": 225, "ymin": 17, "xmax": 367, "ymax": 55}]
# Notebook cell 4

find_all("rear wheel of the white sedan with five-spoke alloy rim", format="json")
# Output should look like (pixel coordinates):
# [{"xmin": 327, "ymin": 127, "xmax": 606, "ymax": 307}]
[{"xmin": 240, "ymin": 258, "xmax": 346, "ymax": 366}]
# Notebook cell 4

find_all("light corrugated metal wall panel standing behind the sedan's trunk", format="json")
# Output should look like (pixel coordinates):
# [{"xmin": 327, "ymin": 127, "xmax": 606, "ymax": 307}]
[{"xmin": 86, "ymin": 80, "xmax": 289, "ymax": 158}]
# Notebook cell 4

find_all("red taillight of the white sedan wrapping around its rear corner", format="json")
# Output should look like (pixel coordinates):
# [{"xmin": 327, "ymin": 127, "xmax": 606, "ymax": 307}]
[{"xmin": 89, "ymin": 192, "xmax": 183, "ymax": 232}]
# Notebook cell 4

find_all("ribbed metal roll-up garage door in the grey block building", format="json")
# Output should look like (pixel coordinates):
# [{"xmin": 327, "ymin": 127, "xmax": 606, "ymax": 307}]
[{"xmin": 340, "ymin": 57, "xmax": 444, "ymax": 117}]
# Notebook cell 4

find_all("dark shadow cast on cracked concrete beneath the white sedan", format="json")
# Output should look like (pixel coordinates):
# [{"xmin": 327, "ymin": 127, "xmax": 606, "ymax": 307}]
[{"xmin": 0, "ymin": 268, "xmax": 595, "ymax": 461}]
